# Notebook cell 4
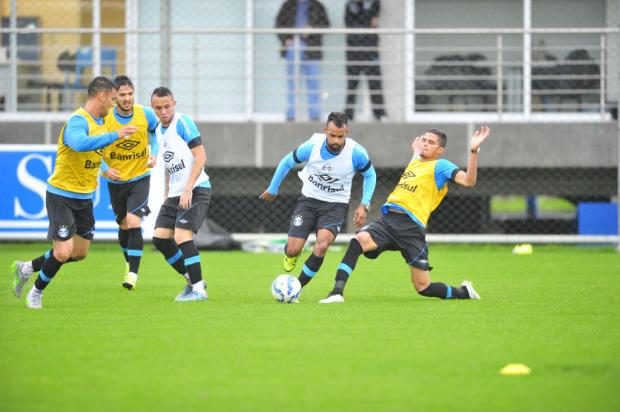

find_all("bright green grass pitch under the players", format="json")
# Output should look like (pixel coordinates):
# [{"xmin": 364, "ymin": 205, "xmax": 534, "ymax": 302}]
[{"xmin": 0, "ymin": 244, "xmax": 620, "ymax": 412}]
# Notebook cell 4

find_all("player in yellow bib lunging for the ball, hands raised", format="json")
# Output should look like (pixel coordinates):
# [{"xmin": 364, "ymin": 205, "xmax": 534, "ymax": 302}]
[{"xmin": 320, "ymin": 127, "xmax": 490, "ymax": 303}]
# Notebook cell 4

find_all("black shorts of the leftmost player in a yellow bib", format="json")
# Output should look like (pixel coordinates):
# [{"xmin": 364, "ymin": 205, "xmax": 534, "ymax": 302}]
[{"xmin": 45, "ymin": 192, "xmax": 95, "ymax": 240}]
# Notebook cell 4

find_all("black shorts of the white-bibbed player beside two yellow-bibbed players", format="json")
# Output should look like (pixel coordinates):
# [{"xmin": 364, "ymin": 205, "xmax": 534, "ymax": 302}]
[{"xmin": 155, "ymin": 187, "xmax": 211, "ymax": 233}]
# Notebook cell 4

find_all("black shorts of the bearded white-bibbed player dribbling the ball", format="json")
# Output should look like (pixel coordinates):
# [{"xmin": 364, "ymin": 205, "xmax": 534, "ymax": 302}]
[{"xmin": 288, "ymin": 196, "xmax": 348, "ymax": 239}]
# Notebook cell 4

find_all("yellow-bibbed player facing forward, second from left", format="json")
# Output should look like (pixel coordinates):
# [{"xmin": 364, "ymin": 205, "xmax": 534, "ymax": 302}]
[{"xmin": 101, "ymin": 76, "xmax": 159, "ymax": 290}]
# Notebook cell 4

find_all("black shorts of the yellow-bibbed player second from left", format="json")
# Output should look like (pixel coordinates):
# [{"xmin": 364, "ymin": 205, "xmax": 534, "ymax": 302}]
[{"xmin": 108, "ymin": 176, "xmax": 151, "ymax": 224}]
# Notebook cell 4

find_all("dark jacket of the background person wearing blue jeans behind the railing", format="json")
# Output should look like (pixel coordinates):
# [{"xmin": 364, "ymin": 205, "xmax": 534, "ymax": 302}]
[{"xmin": 276, "ymin": 0, "xmax": 329, "ymax": 60}]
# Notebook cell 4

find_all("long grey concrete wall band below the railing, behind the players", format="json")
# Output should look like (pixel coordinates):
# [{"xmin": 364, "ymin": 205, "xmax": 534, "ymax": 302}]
[{"xmin": 0, "ymin": 122, "xmax": 618, "ymax": 167}]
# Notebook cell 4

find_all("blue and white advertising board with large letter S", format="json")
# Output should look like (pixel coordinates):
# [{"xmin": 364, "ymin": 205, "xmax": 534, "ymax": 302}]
[{"xmin": 0, "ymin": 145, "xmax": 117, "ymax": 239}]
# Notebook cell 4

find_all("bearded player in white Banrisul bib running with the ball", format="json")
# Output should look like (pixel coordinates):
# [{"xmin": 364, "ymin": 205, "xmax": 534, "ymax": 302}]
[{"xmin": 260, "ymin": 112, "xmax": 377, "ymax": 287}]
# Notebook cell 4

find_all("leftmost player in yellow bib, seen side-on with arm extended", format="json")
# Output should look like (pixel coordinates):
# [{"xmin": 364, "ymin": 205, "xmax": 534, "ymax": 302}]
[{"xmin": 11, "ymin": 76, "xmax": 136, "ymax": 309}]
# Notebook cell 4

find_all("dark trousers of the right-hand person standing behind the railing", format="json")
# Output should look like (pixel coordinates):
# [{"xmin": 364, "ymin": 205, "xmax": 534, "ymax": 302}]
[{"xmin": 345, "ymin": 60, "xmax": 385, "ymax": 119}]
